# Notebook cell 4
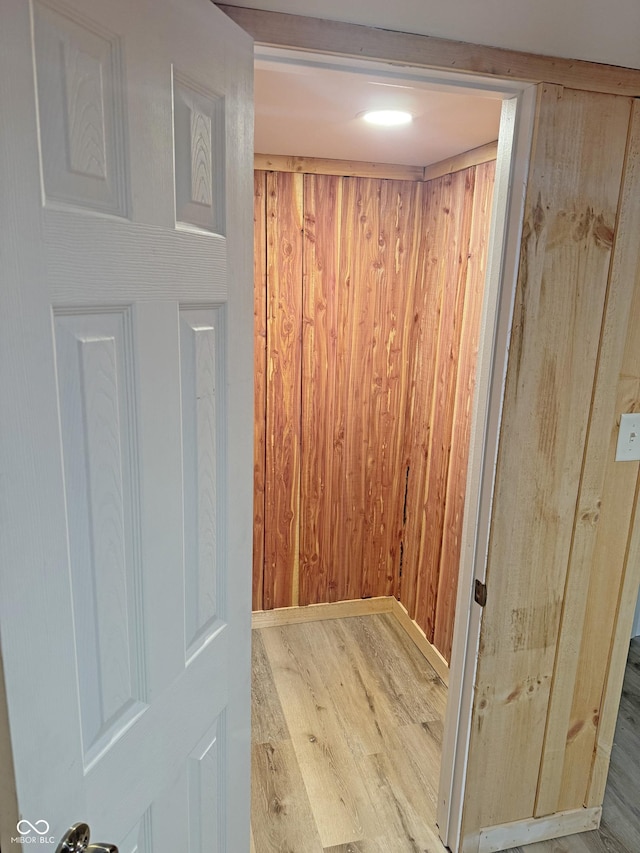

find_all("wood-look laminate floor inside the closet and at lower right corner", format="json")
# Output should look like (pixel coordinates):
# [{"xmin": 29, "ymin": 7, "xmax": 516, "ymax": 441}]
[{"xmin": 251, "ymin": 614, "xmax": 640, "ymax": 853}]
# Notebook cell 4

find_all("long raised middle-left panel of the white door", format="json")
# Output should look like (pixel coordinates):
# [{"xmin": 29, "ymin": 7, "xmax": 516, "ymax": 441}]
[{"xmin": 54, "ymin": 309, "xmax": 146, "ymax": 768}]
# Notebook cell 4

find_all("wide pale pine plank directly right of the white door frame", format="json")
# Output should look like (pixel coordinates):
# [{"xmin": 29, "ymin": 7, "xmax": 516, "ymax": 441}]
[{"xmin": 463, "ymin": 86, "xmax": 630, "ymax": 835}]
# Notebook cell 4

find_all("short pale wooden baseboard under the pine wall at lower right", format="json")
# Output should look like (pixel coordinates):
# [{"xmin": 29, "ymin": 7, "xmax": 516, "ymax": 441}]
[{"xmin": 477, "ymin": 806, "xmax": 602, "ymax": 853}]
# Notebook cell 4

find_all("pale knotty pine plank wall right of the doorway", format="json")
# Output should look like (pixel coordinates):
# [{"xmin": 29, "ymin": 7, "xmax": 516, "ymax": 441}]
[{"xmin": 464, "ymin": 84, "xmax": 640, "ymax": 850}]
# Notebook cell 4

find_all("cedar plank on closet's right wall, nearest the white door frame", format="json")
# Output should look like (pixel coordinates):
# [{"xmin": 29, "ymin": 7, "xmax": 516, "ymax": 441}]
[{"xmin": 433, "ymin": 160, "xmax": 496, "ymax": 660}]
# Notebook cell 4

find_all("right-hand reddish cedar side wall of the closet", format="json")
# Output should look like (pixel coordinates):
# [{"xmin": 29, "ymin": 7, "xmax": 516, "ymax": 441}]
[{"xmin": 400, "ymin": 164, "xmax": 494, "ymax": 644}]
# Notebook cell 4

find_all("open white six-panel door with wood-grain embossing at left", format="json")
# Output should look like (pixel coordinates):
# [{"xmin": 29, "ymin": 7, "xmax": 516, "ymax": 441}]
[{"xmin": 0, "ymin": 0, "xmax": 253, "ymax": 853}]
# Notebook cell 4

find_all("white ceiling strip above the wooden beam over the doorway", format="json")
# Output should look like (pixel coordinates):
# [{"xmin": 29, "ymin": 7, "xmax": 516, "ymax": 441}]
[{"xmin": 221, "ymin": 0, "xmax": 640, "ymax": 68}]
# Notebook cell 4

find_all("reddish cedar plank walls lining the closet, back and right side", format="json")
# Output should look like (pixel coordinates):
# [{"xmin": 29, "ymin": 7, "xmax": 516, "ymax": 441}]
[{"xmin": 253, "ymin": 162, "xmax": 495, "ymax": 660}]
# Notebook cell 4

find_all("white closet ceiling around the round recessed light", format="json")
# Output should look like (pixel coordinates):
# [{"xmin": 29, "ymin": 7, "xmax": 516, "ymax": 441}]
[{"xmin": 255, "ymin": 59, "xmax": 501, "ymax": 166}]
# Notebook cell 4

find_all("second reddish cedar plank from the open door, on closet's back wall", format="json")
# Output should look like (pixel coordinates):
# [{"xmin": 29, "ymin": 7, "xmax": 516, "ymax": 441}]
[{"xmin": 263, "ymin": 172, "xmax": 303, "ymax": 609}]
